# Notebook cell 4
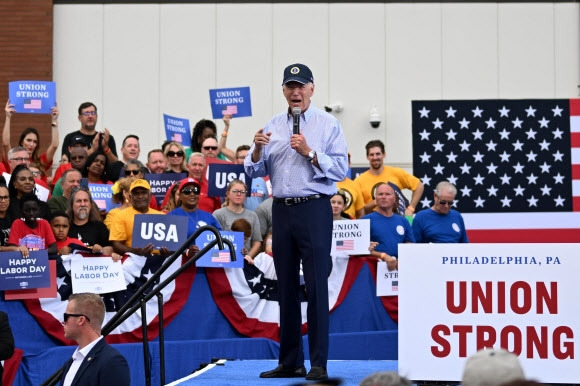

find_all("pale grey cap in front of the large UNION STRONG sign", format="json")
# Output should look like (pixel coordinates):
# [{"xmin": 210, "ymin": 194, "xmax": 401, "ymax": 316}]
[{"xmin": 461, "ymin": 348, "xmax": 525, "ymax": 386}]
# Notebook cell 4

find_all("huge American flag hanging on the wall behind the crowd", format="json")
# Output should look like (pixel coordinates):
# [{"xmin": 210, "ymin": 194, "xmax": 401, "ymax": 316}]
[{"xmin": 412, "ymin": 99, "xmax": 580, "ymax": 242}]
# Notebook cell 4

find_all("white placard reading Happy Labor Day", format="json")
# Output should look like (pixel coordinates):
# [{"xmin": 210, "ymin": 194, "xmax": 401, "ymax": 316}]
[{"xmin": 69, "ymin": 255, "xmax": 127, "ymax": 294}]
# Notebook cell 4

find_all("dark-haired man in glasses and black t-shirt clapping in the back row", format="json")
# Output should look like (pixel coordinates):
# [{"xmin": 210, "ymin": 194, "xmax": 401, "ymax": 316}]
[{"xmin": 62, "ymin": 102, "xmax": 118, "ymax": 164}]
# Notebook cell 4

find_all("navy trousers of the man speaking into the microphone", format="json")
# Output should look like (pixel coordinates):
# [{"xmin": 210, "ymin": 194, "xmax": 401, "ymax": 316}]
[{"xmin": 272, "ymin": 198, "xmax": 332, "ymax": 368}]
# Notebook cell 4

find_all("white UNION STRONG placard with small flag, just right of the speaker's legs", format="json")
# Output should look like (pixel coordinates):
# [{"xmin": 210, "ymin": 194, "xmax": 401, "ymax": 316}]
[{"xmin": 330, "ymin": 219, "xmax": 371, "ymax": 256}]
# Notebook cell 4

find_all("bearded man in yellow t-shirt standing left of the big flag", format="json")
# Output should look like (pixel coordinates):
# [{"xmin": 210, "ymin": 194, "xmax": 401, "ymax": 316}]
[{"xmin": 355, "ymin": 139, "xmax": 425, "ymax": 216}]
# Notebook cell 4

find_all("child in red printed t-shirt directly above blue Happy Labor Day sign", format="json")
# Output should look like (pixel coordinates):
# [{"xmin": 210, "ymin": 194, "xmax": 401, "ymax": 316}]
[{"xmin": 8, "ymin": 193, "xmax": 57, "ymax": 257}]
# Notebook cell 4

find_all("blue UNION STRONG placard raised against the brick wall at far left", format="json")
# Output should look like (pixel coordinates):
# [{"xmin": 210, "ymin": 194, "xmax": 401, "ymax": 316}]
[{"xmin": 8, "ymin": 80, "xmax": 56, "ymax": 114}]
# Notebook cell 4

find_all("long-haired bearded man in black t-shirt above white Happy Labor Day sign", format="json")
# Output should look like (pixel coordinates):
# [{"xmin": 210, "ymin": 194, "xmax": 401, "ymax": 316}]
[{"xmin": 67, "ymin": 188, "xmax": 113, "ymax": 255}]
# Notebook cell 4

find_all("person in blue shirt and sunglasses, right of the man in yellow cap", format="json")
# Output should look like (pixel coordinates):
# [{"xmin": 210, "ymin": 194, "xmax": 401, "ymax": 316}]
[{"xmin": 167, "ymin": 178, "xmax": 222, "ymax": 257}]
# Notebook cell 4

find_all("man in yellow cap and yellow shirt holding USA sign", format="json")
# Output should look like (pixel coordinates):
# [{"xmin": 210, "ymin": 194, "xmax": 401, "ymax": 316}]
[{"xmin": 109, "ymin": 179, "xmax": 163, "ymax": 256}]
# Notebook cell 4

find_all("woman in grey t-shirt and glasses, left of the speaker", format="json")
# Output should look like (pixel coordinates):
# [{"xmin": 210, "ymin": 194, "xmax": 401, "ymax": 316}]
[{"xmin": 213, "ymin": 180, "xmax": 262, "ymax": 262}]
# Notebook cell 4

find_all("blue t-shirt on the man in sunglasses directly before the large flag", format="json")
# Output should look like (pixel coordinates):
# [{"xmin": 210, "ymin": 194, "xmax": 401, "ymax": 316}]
[{"xmin": 413, "ymin": 209, "xmax": 469, "ymax": 243}]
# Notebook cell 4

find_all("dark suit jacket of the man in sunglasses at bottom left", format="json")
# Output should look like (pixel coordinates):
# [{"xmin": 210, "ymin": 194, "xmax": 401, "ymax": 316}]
[{"xmin": 60, "ymin": 338, "xmax": 131, "ymax": 386}]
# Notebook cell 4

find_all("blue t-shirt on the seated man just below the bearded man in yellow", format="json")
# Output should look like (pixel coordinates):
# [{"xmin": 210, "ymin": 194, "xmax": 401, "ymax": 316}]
[{"xmin": 363, "ymin": 212, "xmax": 415, "ymax": 257}]
